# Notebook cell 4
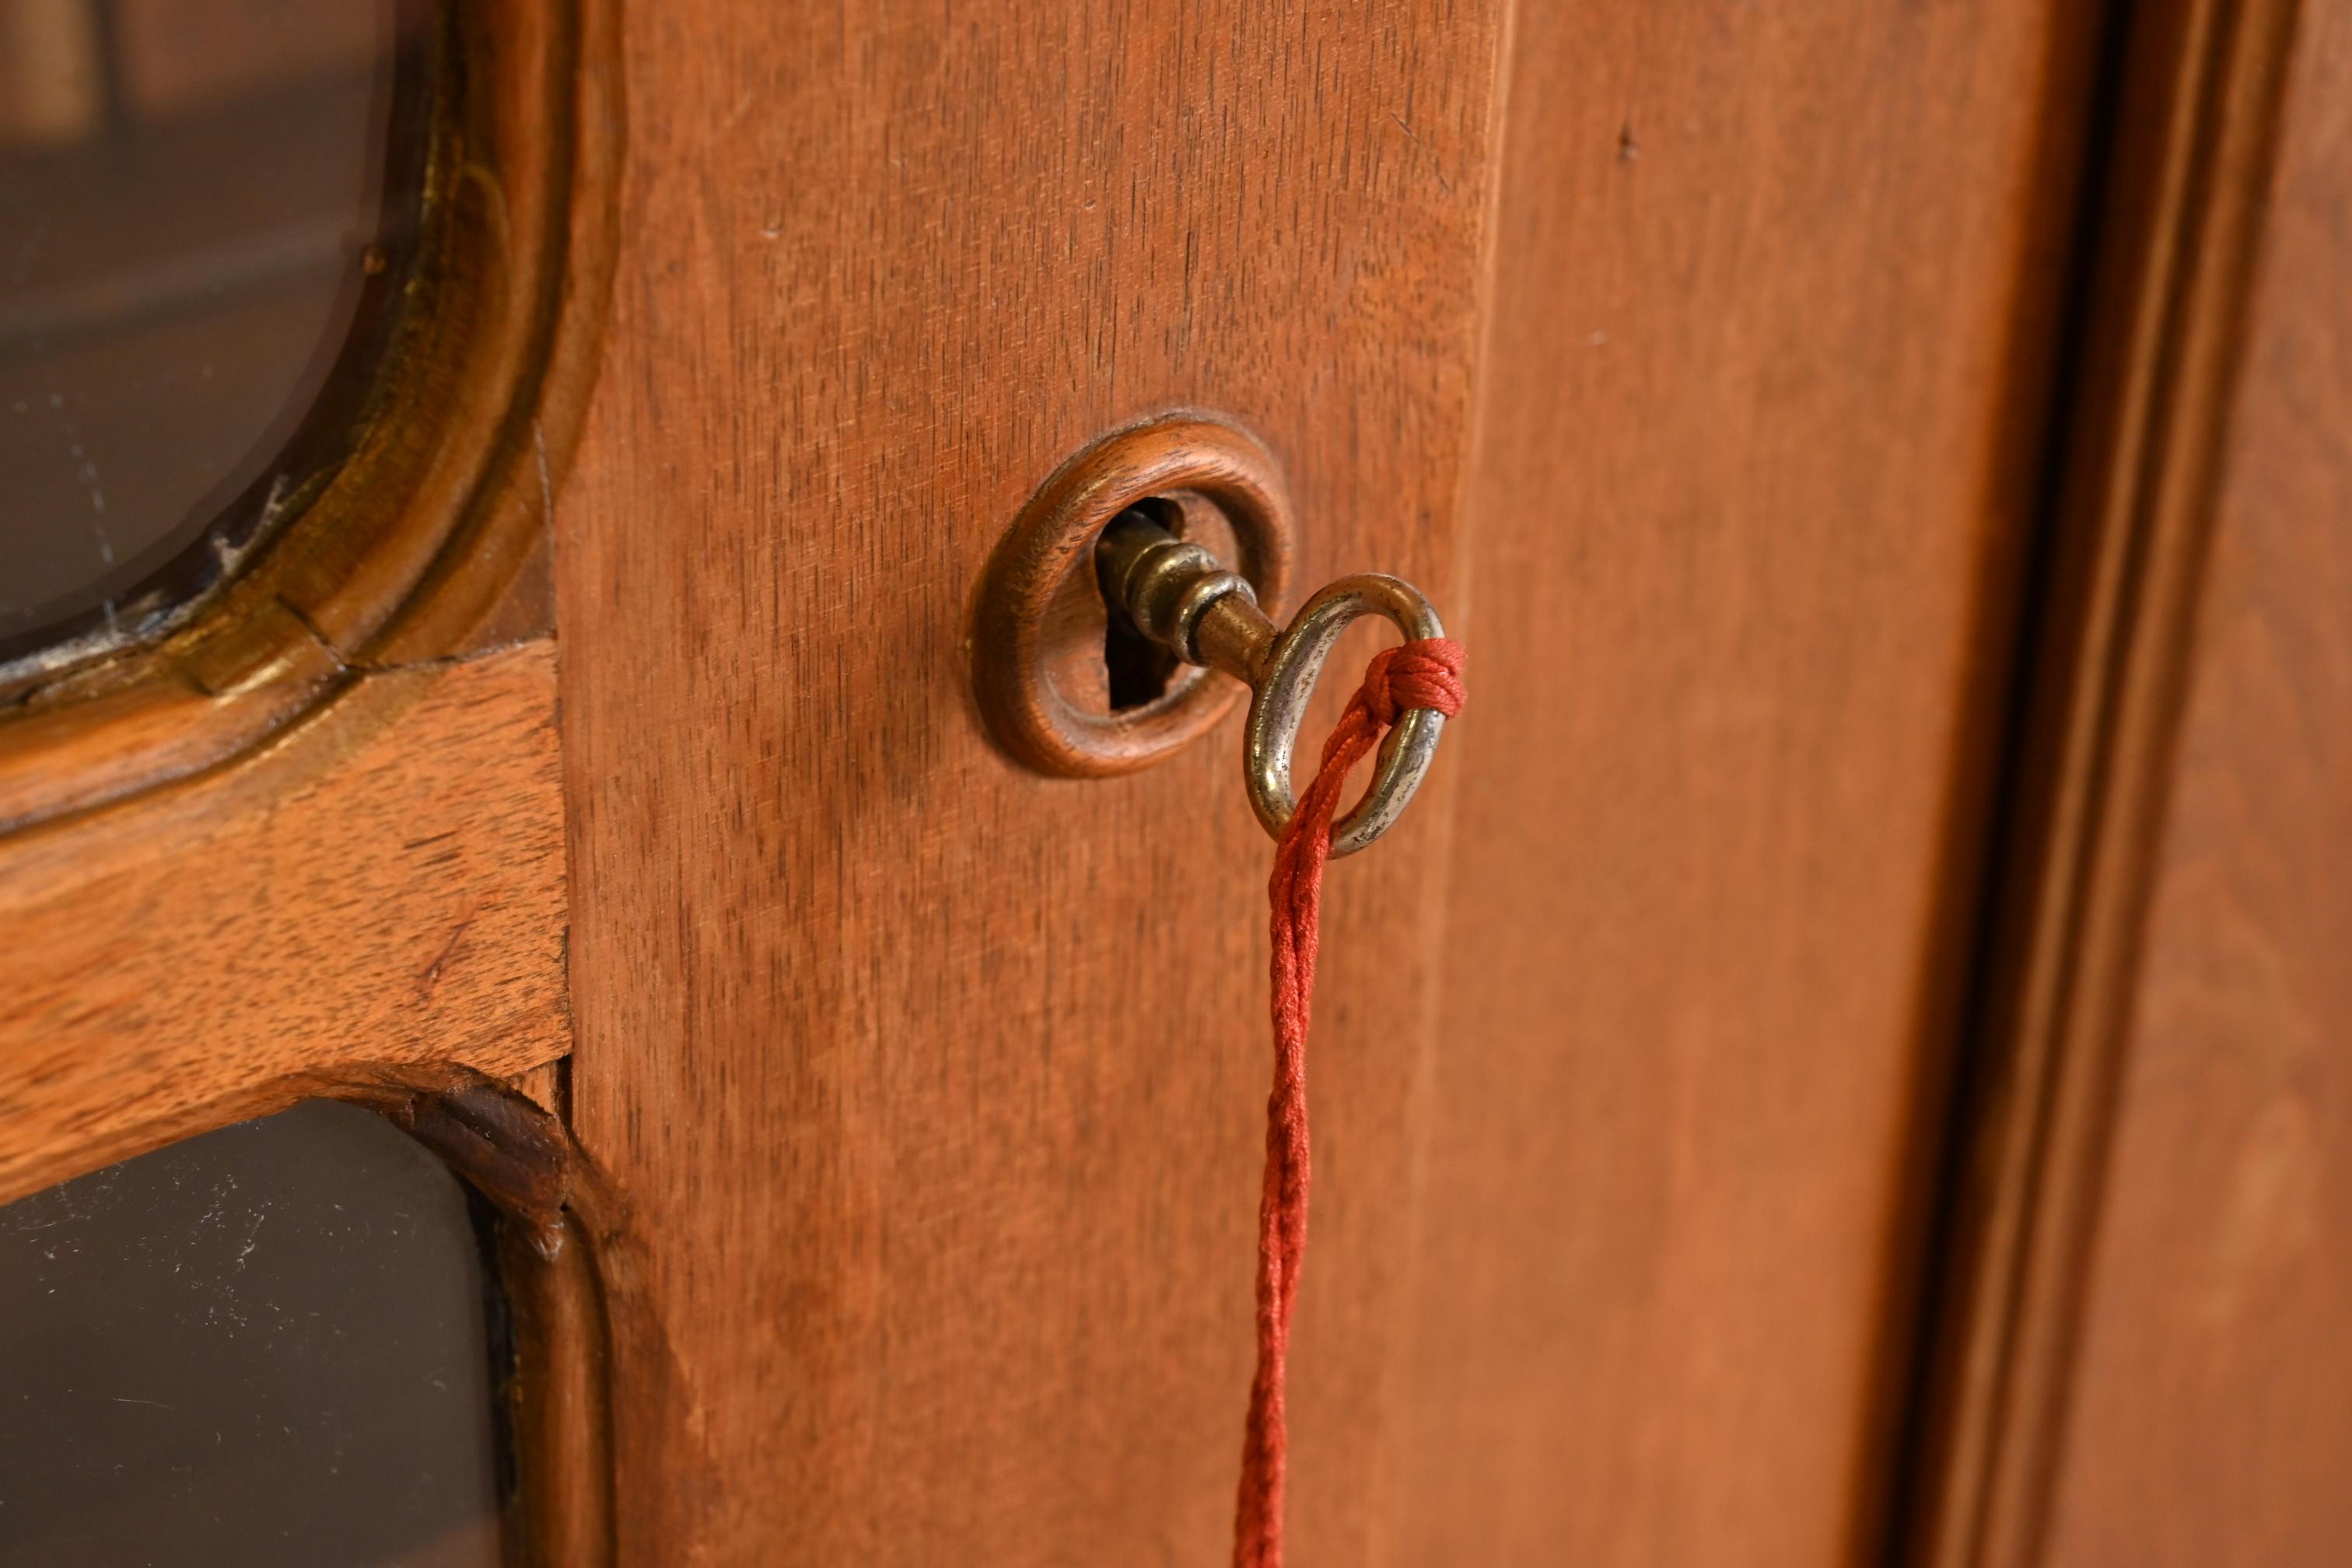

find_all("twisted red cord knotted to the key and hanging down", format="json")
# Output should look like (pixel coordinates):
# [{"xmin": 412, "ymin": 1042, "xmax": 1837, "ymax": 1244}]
[{"xmin": 1233, "ymin": 637, "xmax": 1463, "ymax": 1568}]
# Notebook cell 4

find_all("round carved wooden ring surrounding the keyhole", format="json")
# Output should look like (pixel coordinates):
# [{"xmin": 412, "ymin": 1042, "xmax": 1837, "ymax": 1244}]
[{"xmin": 971, "ymin": 414, "xmax": 1291, "ymax": 778}]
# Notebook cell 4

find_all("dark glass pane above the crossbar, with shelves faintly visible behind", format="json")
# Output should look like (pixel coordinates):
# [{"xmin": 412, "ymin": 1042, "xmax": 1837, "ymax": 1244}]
[{"xmin": 0, "ymin": 0, "xmax": 425, "ymax": 663}]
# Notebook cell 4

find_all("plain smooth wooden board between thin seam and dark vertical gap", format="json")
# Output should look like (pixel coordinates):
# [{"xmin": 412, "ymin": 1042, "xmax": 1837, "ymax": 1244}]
[{"xmin": 1374, "ymin": 0, "xmax": 2095, "ymax": 1568}]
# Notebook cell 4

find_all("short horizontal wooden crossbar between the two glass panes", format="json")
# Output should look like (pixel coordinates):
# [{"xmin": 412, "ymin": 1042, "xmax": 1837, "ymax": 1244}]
[{"xmin": 0, "ymin": 642, "xmax": 569, "ymax": 1201}]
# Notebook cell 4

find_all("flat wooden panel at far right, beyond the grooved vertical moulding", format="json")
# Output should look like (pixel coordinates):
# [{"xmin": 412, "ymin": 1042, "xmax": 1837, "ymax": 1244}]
[{"xmin": 2021, "ymin": 0, "xmax": 2352, "ymax": 1568}]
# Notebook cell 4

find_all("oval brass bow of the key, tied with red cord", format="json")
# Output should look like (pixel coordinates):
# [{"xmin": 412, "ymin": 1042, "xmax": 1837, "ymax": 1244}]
[{"xmin": 1242, "ymin": 571, "xmax": 1447, "ymax": 856}]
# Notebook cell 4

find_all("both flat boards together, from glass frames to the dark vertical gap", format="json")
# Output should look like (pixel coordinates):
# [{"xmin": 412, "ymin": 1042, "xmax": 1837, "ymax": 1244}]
[{"xmin": 555, "ymin": 2, "xmax": 2098, "ymax": 1563}]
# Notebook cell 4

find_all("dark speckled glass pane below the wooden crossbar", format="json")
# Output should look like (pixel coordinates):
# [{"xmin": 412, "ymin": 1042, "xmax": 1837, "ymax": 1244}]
[{"xmin": 0, "ymin": 1101, "xmax": 499, "ymax": 1568}]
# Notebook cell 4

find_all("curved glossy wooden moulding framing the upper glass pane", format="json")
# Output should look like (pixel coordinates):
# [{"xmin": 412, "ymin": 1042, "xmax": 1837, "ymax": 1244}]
[{"xmin": 0, "ymin": 0, "xmax": 623, "ymax": 839}]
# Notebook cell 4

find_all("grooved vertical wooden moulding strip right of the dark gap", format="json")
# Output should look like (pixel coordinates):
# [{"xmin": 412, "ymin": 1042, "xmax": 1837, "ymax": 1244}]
[{"xmin": 1891, "ymin": 0, "xmax": 2295, "ymax": 1568}]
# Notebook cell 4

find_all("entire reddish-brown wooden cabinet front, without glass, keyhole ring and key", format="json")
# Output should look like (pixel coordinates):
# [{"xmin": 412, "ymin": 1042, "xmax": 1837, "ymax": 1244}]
[{"xmin": 0, "ymin": 0, "xmax": 2352, "ymax": 1568}]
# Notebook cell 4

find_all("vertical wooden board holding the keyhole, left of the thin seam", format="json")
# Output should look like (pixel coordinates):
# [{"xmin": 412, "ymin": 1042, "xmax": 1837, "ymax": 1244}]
[{"xmin": 558, "ymin": 0, "xmax": 1496, "ymax": 1566}]
